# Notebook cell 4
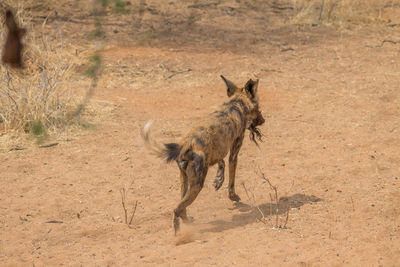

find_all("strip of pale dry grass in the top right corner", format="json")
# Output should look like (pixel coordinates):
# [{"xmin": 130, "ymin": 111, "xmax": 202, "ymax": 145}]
[{"xmin": 290, "ymin": 0, "xmax": 399, "ymax": 28}]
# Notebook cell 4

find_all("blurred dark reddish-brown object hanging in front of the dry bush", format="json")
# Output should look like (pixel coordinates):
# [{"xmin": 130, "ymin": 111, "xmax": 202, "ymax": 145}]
[{"xmin": 1, "ymin": 10, "xmax": 26, "ymax": 68}]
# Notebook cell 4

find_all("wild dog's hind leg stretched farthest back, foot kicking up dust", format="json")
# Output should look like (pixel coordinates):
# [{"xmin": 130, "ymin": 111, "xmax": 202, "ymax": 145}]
[{"xmin": 173, "ymin": 160, "xmax": 207, "ymax": 235}]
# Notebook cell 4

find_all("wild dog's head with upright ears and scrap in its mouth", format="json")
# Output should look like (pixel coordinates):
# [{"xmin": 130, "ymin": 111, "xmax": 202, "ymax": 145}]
[{"xmin": 221, "ymin": 75, "xmax": 265, "ymax": 145}]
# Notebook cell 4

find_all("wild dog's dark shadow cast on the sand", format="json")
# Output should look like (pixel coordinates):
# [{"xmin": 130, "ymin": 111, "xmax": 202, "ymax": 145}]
[{"xmin": 201, "ymin": 194, "xmax": 321, "ymax": 232}]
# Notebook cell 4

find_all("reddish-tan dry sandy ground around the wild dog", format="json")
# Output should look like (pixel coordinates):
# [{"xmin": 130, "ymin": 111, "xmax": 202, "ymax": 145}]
[{"xmin": 0, "ymin": 1, "xmax": 400, "ymax": 266}]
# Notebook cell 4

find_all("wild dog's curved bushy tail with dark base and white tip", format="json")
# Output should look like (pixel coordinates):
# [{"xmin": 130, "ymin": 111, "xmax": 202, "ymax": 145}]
[{"xmin": 140, "ymin": 120, "xmax": 181, "ymax": 162}]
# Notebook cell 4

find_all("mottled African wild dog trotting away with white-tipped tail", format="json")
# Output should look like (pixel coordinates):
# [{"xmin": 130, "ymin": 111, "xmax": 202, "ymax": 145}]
[{"xmin": 141, "ymin": 75, "xmax": 264, "ymax": 234}]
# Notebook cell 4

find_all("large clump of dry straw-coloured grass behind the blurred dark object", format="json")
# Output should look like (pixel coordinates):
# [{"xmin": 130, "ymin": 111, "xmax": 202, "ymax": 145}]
[{"xmin": 0, "ymin": 1, "xmax": 109, "ymax": 147}]
